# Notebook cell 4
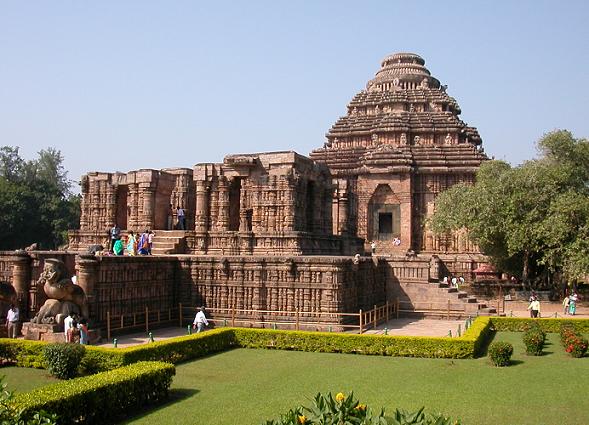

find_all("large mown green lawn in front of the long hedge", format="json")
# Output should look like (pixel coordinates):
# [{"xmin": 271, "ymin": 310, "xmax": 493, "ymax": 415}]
[{"xmin": 128, "ymin": 333, "xmax": 589, "ymax": 425}]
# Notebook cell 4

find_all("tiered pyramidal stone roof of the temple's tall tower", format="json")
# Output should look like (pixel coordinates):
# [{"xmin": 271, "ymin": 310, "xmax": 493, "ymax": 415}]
[{"xmin": 311, "ymin": 53, "xmax": 486, "ymax": 175}]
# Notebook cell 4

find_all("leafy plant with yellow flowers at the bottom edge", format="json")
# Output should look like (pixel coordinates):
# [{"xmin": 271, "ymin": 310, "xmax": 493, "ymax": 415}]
[{"xmin": 264, "ymin": 393, "xmax": 460, "ymax": 425}]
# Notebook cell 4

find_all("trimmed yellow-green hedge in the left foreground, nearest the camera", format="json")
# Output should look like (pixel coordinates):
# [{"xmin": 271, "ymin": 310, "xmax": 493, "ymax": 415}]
[{"xmin": 14, "ymin": 362, "xmax": 176, "ymax": 424}]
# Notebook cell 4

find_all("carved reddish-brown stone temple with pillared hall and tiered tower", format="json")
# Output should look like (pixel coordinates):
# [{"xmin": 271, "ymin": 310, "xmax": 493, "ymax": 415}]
[{"xmin": 0, "ymin": 53, "xmax": 492, "ymax": 338}]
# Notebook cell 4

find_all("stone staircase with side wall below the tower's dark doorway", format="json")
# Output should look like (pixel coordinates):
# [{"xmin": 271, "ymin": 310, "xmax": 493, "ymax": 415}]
[{"xmin": 399, "ymin": 282, "xmax": 497, "ymax": 318}]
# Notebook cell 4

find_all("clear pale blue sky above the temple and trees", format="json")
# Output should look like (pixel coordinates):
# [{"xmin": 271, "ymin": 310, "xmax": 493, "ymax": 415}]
[{"xmin": 0, "ymin": 0, "xmax": 589, "ymax": 187}]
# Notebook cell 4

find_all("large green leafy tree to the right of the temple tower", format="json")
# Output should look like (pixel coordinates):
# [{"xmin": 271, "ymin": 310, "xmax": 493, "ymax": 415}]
[{"xmin": 430, "ymin": 130, "xmax": 589, "ymax": 284}]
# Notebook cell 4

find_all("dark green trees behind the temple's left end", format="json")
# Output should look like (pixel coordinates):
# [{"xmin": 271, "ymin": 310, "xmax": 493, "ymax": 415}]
[{"xmin": 0, "ymin": 146, "xmax": 80, "ymax": 249}]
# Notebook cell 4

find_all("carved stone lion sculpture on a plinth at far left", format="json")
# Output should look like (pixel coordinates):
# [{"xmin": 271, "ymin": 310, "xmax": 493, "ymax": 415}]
[{"xmin": 31, "ymin": 258, "xmax": 88, "ymax": 324}]
